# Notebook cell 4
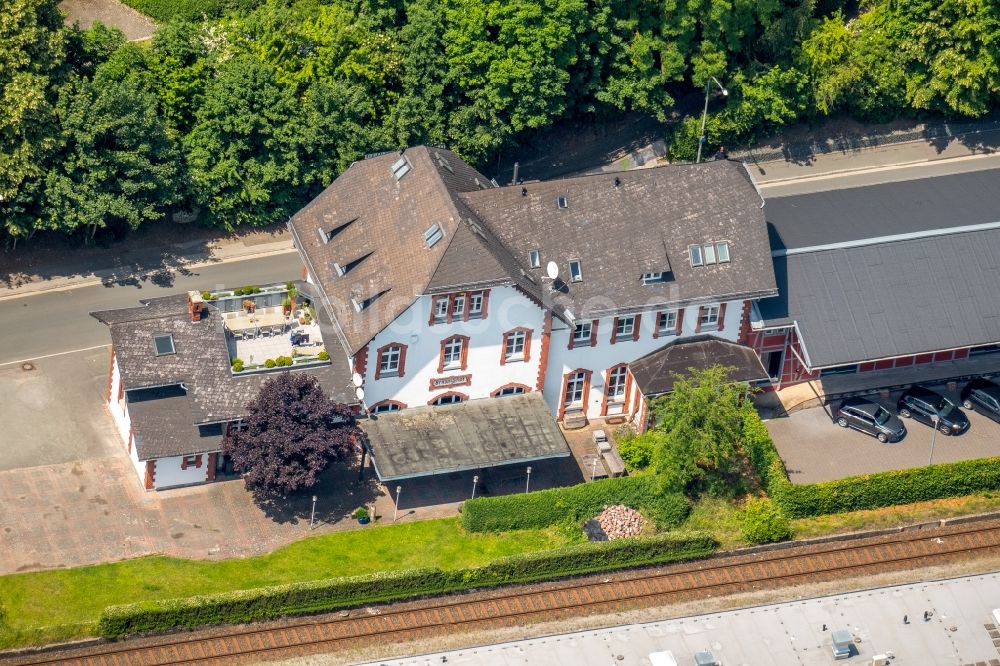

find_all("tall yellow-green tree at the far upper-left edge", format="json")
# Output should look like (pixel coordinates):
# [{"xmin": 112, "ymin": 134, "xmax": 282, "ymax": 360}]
[{"xmin": 0, "ymin": 0, "xmax": 65, "ymax": 238}]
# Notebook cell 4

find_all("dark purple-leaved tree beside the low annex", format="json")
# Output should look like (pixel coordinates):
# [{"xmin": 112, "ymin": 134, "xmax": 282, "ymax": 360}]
[{"xmin": 222, "ymin": 372, "xmax": 365, "ymax": 499}]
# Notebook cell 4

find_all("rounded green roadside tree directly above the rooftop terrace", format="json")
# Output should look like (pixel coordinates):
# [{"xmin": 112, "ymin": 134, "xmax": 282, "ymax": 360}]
[{"xmin": 184, "ymin": 56, "xmax": 307, "ymax": 229}]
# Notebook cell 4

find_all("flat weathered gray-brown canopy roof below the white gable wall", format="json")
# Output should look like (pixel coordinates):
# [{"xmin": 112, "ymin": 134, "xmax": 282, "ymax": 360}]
[{"xmin": 360, "ymin": 393, "xmax": 571, "ymax": 482}]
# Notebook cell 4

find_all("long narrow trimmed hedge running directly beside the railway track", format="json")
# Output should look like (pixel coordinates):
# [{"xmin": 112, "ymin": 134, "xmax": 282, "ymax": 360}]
[{"xmin": 98, "ymin": 534, "xmax": 718, "ymax": 639}]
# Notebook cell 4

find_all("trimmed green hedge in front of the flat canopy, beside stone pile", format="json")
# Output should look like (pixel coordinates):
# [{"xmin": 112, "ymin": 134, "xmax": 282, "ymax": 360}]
[{"xmin": 462, "ymin": 476, "xmax": 691, "ymax": 532}]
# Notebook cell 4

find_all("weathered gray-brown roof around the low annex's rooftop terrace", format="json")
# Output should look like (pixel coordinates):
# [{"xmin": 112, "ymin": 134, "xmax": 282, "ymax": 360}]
[{"xmin": 91, "ymin": 296, "xmax": 357, "ymax": 455}]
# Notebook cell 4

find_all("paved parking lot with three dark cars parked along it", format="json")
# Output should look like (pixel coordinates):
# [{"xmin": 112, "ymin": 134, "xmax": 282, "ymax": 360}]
[{"xmin": 767, "ymin": 387, "xmax": 1000, "ymax": 483}]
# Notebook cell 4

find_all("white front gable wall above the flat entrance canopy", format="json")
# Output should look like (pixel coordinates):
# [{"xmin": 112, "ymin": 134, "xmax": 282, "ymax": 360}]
[{"xmin": 364, "ymin": 287, "xmax": 544, "ymax": 407}]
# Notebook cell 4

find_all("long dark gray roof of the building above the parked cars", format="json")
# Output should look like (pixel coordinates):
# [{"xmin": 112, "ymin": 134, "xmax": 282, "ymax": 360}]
[{"xmin": 759, "ymin": 169, "xmax": 1000, "ymax": 369}]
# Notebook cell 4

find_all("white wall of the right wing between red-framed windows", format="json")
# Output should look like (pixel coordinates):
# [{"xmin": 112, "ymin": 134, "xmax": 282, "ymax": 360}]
[{"xmin": 544, "ymin": 301, "xmax": 743, "ymax": 419}]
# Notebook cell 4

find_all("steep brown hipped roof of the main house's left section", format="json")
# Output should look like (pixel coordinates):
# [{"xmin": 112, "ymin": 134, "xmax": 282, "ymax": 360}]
[{"xmin": 289, "ymin": 146, "xmax": 505, "ymax": 354}]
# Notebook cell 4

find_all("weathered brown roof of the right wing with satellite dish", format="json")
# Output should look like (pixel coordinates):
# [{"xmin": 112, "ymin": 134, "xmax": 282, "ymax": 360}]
[{"xmin": 460, "ymin": 161, "xmax": 776, "ymax": 317}]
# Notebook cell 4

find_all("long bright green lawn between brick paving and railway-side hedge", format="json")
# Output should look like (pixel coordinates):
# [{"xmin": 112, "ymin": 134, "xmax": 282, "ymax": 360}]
[{"xmin": 0, "ymin": 518, "xmax": 582, "ymax": 648}]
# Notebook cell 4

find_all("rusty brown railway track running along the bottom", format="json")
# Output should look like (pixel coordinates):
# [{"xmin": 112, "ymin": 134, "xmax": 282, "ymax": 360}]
[{"xmin": 13, "ymin": 522, "xmax": 1000, "ymax": 666}]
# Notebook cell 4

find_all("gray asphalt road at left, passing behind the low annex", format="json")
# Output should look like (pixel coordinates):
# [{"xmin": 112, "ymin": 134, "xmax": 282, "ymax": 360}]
[{"xmin": 0, "ymin": 253, "xmax": 302, "ymax": 365}]
